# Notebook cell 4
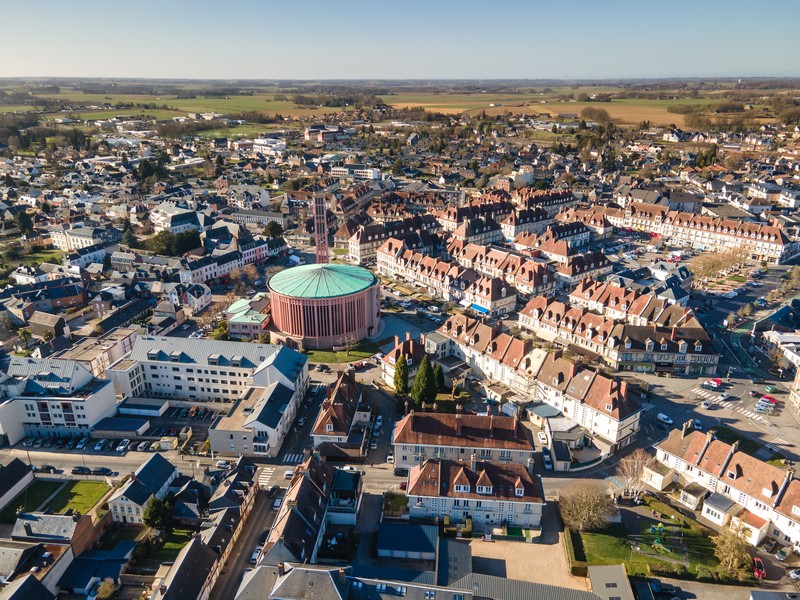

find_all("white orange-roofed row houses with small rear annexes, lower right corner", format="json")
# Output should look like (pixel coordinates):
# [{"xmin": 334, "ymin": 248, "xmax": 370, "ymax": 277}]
[{"xmin": 643, "ymin": 421, "xmax": 800, "ymax": 550}]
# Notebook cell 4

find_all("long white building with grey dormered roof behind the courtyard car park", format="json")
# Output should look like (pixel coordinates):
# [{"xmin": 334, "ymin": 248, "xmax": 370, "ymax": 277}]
[{"xmin": 106, "ymin": 335, "xmax": 294, "ymax": 402}]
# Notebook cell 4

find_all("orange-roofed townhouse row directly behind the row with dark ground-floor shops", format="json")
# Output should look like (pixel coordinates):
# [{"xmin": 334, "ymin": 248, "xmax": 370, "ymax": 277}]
[{"xmin": 569, "ymin": 277, "xmax": 702, "ymax": 328}]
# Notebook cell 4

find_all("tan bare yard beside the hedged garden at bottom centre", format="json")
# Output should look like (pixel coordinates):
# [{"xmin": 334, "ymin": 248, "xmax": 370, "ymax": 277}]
[{"xmin": 470, "ymin": 502, "xmax": 589, "ymax": 590}]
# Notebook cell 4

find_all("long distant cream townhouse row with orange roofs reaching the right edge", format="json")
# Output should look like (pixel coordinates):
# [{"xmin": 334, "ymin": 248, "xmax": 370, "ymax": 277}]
[{"xmin": 595, "ymin": 203, "xmax": 800, "ymax": 264}]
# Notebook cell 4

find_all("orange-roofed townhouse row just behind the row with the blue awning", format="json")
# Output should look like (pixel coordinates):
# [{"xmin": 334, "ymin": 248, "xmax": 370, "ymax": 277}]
[{"xmin": 447, "ymin": 240, "xmax": 556, "ymax": 296}]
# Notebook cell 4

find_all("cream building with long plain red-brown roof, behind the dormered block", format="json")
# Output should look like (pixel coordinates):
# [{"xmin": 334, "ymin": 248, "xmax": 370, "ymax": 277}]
[{"xmin": 392, "ymin": 411, "xmax": 534, "ymax": 467}]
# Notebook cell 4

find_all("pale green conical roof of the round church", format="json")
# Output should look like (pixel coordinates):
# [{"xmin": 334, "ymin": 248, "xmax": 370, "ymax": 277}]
[{"xmin": 269, "ymin": 263, "xmax": 377, "ymax": 298}]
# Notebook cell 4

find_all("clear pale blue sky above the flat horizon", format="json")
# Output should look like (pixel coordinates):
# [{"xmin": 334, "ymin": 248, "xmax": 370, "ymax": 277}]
[{"xmin": 0, "ymin": 0, "xmax": 800, "ymax": 79}]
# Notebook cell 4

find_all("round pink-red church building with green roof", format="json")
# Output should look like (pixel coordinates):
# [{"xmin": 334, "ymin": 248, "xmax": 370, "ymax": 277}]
[{"xmin": 269, "ymin": 263, "xmax": 381, "ymax": 348}]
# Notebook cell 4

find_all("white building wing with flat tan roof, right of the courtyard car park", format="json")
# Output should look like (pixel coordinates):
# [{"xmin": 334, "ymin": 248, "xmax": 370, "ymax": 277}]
[{"xmin": 208, "ymin": 344, "xmax": 309, "ymax": 457}]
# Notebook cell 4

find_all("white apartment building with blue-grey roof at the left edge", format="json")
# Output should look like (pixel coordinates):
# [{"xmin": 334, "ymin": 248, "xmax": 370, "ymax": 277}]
[{"xmin": 0, "ymin": 356, "xmax": 117, "ymax": 445}]
